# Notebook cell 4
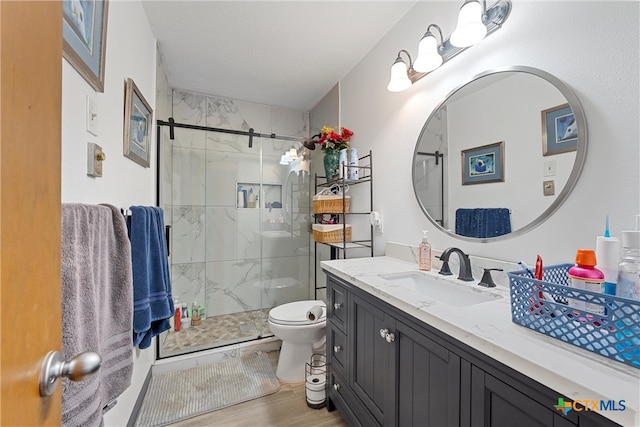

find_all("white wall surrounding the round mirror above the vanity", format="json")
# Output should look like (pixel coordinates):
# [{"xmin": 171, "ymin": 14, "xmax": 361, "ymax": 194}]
[{"xmin": 340, "ymin": 0, "xmax": 640, "ymax": 264}]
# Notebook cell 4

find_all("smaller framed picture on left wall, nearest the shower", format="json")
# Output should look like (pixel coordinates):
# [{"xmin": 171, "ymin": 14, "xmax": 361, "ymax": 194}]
[{"xmin": 124, "ymin": 79, "xmax": 153, "ymax": 168}]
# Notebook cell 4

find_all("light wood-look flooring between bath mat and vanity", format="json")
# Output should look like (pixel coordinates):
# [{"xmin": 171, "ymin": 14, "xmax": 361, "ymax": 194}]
[{"xmin": 164, "ymin": 352, "xmax": 347, "ymax": 427}]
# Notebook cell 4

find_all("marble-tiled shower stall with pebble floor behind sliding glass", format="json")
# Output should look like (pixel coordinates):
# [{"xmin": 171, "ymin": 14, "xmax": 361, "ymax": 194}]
[{"xmin": 157, "ymin": 119, "xmax": 312, "ymax": 358}]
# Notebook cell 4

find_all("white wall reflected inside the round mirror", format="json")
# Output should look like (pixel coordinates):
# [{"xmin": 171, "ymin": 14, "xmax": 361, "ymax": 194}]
[{"xmin": 446, "ymin": 73, "xmax": 576, "ymax": 230}]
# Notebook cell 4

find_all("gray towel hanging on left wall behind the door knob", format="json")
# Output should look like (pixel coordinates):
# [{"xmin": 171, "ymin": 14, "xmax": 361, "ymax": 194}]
[{"xmin": 62, "ymin": 204, "xmax": 133, "ymax": 426}]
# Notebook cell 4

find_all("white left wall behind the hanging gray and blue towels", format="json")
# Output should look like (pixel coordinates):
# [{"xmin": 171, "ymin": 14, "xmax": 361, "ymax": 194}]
[{"xmin": 62, "ymin": 1, "xmax": 156, "ymax": 426}]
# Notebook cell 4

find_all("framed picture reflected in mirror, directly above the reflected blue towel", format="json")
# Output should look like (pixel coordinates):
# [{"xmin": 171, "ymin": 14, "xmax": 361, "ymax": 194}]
[{"xmin": 461, "ymin": 141, "xmax": 504, "ymax": 185}]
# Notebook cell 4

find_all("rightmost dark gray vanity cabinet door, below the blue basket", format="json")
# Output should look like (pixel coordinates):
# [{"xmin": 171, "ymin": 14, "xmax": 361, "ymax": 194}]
[{"xmin": 471, "ymin": 366, "xmax": 572, "ymax": 427}]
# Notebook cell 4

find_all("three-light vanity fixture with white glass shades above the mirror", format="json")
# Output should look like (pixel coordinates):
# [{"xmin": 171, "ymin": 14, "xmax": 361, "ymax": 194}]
[{"xmin": 387, "ymin": 0, "xmax": 511, "ymax": 92}]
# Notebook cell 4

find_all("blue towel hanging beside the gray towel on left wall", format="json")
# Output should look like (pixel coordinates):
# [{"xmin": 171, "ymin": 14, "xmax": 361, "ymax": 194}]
[{"xmin": 129, "ymin": 206, "xmax": 174, "ymax": 349}]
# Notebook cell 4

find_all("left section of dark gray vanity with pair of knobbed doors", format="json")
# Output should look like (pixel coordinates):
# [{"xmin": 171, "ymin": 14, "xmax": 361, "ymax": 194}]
[{"xmin": 327, "ymin": 276, "xmax": 460, "ymax": 426}]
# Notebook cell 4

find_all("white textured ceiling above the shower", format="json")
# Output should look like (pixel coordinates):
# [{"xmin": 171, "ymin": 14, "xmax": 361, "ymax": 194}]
[{"xmin": 143, "ymin": 0, "xmax": 417, "ymax": 111}]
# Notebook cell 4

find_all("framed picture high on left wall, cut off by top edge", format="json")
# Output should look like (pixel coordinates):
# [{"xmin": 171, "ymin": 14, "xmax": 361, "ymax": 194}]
[{"xmin": 62, "ymin": 0, "xmax": 109, "ymax": 92}]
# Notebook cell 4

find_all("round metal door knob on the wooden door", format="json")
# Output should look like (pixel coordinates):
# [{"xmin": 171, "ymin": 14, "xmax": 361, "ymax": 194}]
[{"xmin": 39, "ymin": 351, "xmax": 102, "ymax": 397}]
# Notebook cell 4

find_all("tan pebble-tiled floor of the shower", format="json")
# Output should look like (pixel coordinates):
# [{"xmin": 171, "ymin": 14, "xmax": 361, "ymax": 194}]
[{"xmin": 160, "ymin": 309, "xmax": 273, "ymax": 357}]
